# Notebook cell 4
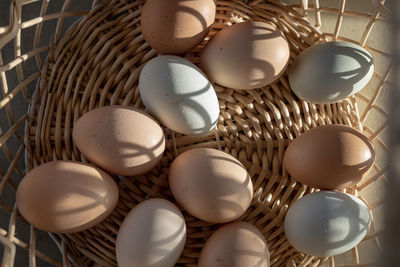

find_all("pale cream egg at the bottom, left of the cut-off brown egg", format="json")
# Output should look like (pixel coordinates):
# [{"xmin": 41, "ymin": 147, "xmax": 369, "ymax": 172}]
[{"xmin": 116, "ymin": 198, "xmax": 186, "ymax": 267}]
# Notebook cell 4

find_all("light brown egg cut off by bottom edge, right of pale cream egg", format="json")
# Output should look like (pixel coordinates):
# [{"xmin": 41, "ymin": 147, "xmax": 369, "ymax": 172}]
[{"xmin": 198, "ymin": 222, "xmax": 270, "ymax": 267}]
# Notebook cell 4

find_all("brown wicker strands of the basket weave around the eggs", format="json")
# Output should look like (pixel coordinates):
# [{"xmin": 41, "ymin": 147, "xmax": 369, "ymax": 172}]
[{"xmin": 0, "ymin": 0, "xmax": 391, "ymax": 267}]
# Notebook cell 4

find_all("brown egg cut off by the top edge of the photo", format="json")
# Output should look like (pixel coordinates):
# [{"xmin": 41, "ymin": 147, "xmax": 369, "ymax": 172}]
[{"xmin": 141, "ymin": 0, "xmax": 216, "ymax": 54}]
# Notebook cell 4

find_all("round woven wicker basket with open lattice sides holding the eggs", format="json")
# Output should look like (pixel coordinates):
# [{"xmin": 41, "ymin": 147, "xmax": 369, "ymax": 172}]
[{"xmin": 0, "ymin": 0, "xmax": 391, "ymax": 267}]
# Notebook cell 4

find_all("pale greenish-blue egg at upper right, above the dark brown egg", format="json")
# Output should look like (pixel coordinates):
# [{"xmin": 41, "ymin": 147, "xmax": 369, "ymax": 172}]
[{"xmin": 289, "ymin": 41, "xmax": 374, "ymax": 103}]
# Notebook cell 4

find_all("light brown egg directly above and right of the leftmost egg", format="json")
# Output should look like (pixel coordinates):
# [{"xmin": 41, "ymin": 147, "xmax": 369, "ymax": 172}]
[{"xmin": 72, "ymin": 106, "xmax": 165, "ymax": 176}]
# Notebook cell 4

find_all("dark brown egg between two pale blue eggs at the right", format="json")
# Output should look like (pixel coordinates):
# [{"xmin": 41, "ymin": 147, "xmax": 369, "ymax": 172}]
[{"xmin": 283, "ymin": 125, "xmax": 375, "ymax": 189}]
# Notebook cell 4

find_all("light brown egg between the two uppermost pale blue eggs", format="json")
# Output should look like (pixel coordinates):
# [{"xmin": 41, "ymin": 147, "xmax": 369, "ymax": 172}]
[{"xmin": 200, "ymin": 21, "xmax": 290, "ymax": 89}]
